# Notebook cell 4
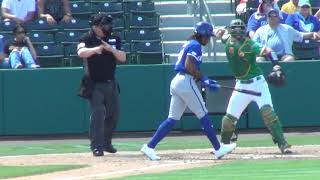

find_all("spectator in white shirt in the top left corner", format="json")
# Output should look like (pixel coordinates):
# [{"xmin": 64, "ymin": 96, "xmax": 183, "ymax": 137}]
[{"xmin": 1, "ymin": 0, "xmax": 36, "ymax": 23}]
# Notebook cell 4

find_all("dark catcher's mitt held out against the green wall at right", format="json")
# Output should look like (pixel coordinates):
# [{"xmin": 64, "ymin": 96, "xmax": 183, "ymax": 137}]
[{"xmin": 267, "ymin": 65, "xmax": 286, "ymax": 87}]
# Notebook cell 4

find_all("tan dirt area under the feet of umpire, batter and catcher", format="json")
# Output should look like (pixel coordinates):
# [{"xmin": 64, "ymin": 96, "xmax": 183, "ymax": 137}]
[{"xmin": 0, "ymin": 145, "xmax": 320, "ymax": 180}]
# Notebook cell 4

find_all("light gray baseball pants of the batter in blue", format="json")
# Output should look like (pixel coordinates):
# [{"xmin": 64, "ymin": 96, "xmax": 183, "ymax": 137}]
[{"xmin": 168, "ymin": 73, "xmax": 208, "ymax": 120}]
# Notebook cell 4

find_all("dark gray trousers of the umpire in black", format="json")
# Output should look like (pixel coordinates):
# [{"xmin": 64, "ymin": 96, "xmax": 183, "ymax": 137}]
[{"xmin": 89, "ymin": 81, "xmax": 120, "ymax": 150}]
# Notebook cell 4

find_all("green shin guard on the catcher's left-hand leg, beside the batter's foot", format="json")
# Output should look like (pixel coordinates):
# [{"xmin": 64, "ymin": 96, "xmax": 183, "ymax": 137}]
[{"xmin": 221, "ymin": 114, "xmax": 238, "ymax": 144}]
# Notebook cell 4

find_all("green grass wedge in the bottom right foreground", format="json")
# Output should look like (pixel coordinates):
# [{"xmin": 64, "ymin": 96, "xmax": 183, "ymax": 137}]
[{"xmin": 117, "ymin": 160, "xmax": 320, "ymax": 180}]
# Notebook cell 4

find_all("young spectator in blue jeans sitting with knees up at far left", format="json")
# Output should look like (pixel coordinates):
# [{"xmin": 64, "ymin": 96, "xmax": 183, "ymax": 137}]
[{"xmin": 4, "ymin": 24, "xmax": 39, "ymax": 69}]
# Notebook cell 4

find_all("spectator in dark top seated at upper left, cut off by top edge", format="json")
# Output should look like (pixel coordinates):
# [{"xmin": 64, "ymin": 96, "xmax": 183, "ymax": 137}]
[{"xmin": 38, "ymin": 0, "xmax": 73, "ymax": 24}]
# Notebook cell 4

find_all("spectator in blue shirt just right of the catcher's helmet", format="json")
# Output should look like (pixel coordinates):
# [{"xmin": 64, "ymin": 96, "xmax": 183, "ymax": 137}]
[{"xmin": 247, "ymin": 0, "xmax": 279, "ymax": 38}]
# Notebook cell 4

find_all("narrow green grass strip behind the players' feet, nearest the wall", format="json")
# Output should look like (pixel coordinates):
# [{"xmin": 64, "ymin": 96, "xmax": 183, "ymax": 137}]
[{"xmin": 0, "ymin": 135, "xmax": 320, "ymax": 156}]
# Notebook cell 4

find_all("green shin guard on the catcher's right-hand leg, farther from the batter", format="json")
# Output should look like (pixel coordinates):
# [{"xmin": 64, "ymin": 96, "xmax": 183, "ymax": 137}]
[{"xmin": 260, "ymin": 105, "xmax": 291, "ymax": 153}]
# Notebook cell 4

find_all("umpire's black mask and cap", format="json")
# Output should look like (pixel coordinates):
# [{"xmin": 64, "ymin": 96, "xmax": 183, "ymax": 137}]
[{"xmin": 89, "ymin": 12, "xmax": 112, "ymax": 36}]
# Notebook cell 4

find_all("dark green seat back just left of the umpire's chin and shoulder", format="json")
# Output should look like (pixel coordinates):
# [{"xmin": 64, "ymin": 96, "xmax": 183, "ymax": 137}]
[{"xmin": 55, "ymin": 31, "xmax": 83, "ymax": 45}]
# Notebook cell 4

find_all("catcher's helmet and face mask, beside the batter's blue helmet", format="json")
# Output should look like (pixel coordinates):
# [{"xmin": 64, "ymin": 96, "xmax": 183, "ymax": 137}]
[{"xmin": 228, "ymin": 19, "xmax": 246, "ymax": 41}]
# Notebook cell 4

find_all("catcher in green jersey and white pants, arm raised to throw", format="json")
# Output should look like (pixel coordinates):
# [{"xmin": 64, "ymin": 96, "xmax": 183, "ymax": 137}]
[{"xmin": 221, "ymin": 19, "xmax": 291, "ymax": 154}]
